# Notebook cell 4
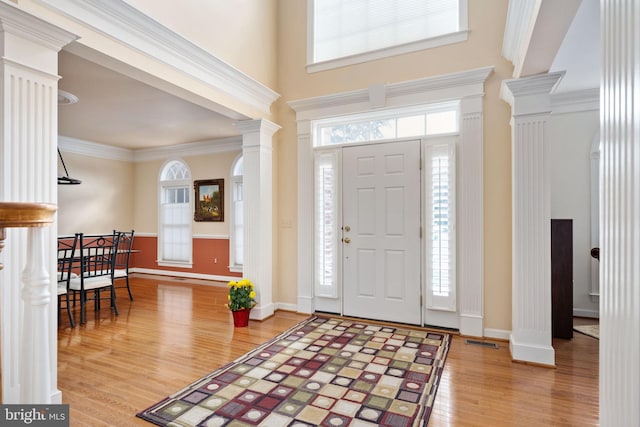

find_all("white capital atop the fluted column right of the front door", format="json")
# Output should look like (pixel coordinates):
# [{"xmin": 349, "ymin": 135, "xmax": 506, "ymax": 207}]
[{"xmin": 500, "ymin": 71, "xmax": 564, "ymax": 117}]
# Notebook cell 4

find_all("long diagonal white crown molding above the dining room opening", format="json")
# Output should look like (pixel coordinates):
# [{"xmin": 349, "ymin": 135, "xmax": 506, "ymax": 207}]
[{"xmin": 36, "ymin": 0, "xmax": 280, "ymax": 113}]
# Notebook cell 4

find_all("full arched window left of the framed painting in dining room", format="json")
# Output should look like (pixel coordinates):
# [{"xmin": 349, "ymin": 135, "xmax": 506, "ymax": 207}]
[{"xmin": 158, "ymin": 160, "xmax": 192, "ymax": 267}]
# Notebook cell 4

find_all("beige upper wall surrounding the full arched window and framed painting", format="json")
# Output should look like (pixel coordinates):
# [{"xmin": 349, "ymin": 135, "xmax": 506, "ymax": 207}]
[{"xmin": 133, "ymin": 151, "xmax": 240, "ymax": 236}]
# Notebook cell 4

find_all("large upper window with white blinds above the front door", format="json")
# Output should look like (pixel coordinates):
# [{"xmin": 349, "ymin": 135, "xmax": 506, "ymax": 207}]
[{"xmin": 308, "ymin": 0, "xmax": 467, "ymax": 71}]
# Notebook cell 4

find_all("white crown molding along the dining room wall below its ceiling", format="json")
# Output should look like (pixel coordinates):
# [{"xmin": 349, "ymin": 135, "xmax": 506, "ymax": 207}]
[{"xmin": 58, "ymin": 136, "xmax": 242, "ymax": 163}]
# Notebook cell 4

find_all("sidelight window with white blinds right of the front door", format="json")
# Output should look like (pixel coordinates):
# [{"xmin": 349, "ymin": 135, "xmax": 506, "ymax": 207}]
[{"xmin": 424, "ymin": 143, "xmax": 456, "ymax": 311}]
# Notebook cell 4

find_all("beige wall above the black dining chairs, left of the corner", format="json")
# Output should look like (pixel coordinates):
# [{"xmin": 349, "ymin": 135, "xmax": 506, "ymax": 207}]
[{"xmin": 58, "ymin": 152, "xmax": 134, "ymax": 235}]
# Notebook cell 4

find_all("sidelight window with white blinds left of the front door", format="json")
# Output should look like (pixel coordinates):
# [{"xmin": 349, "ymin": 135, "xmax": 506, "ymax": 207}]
[{"xmin": 314, "ymin": 150, "xmax": 340, "ymax": 298}]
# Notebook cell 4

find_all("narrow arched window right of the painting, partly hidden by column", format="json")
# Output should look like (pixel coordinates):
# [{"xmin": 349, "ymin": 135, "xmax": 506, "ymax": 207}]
[{"xmin": 229, "ymin": 154, "xmax": 244, "ymax": 272}]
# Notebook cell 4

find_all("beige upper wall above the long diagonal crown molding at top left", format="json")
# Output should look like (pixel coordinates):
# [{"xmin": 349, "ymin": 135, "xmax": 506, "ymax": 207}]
[{"xmin": 127, "ymin": 0, "xmax": 276, "ymax": 88}]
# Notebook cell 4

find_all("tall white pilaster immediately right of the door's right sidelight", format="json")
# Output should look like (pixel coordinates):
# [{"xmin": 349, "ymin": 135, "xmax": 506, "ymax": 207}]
[{"xmin": 458, "ymin": 95, "xmax": 484, "ymax": 337}]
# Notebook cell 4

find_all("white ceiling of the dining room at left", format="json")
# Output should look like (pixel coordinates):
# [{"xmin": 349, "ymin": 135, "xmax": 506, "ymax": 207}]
[{"xmin": 58, "ymin": 51, "xmax": 239, "ymax": 149}]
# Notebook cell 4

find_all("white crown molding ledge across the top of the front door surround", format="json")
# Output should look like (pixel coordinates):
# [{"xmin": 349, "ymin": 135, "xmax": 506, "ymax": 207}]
[{"xmin": 287, "ymin": 66, "xmax": 493, "ymax": 121}]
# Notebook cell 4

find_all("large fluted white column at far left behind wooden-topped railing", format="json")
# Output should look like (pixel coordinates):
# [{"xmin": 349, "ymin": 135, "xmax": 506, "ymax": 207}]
[{"xmin": 0, "ymin": 2, "xmax": 76, "ymax": 403}]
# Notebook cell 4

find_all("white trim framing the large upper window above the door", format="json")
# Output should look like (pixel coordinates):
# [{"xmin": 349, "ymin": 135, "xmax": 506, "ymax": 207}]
[{"xmin": 307, "ymin": 0, "xmax": 469, "ymax": 73}]
